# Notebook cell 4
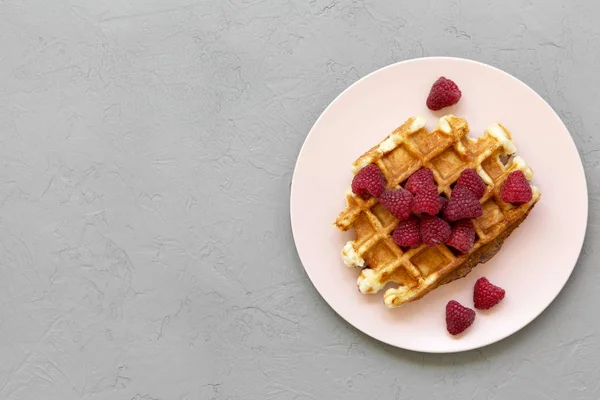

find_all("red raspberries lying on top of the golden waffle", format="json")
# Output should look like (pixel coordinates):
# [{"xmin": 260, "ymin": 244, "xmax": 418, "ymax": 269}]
[{"xmin": 352, "ymin": 164, "xmax": 532, "ymax": 253}]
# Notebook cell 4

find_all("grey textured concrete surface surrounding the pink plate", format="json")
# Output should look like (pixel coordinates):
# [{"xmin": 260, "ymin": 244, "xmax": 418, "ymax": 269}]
[{"xmin": 0, "ymin": 0, "xmax": 600, "ymax": 400}]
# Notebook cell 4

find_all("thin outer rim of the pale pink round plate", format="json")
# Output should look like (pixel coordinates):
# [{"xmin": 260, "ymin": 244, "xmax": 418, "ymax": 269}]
[{"xmin": 289, "ymin": 56, "xmax": 589, "ymax": 354}]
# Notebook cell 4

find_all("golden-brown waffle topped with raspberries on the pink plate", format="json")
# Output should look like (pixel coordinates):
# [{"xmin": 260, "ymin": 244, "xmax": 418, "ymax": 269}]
[{"xmin": 334, "ymin": 115, "xmax": 540, "ymax": 307}]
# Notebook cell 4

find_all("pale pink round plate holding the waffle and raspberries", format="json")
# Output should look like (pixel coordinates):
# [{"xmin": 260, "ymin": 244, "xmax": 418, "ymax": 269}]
[{"xmin": 290, "ymin": 57, "xmax": 588, "ymax": 353}]
